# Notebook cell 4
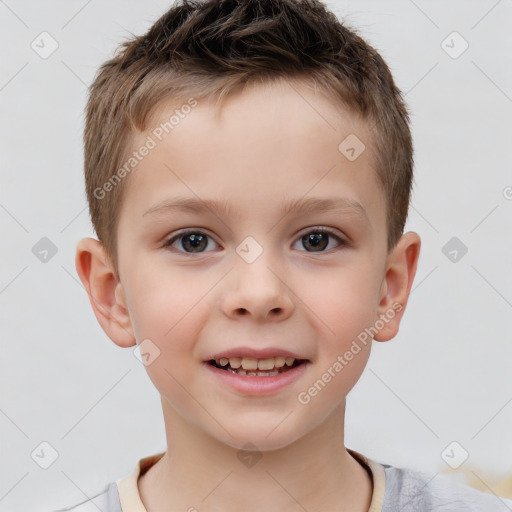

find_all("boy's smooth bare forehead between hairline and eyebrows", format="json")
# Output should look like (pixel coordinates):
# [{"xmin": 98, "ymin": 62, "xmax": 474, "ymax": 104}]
[{"xmin": 118, "ymin": 80, "xmax": 385, "ymax": 236}]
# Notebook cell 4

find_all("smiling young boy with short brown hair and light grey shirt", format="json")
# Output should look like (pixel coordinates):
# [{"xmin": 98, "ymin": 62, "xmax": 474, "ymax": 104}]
[{"xmin": 64, "ymin": 0, "xmax": 512, "ymax": 512}]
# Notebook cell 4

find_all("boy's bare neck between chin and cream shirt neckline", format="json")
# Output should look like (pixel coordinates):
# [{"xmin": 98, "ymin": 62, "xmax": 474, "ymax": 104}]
[{"xmin": 138, "ymin": 402, "xmax": 372, "ymax": 512}]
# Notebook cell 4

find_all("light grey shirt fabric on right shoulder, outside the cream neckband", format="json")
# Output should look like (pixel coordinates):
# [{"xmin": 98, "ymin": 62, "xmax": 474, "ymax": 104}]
[{"xmin": 382, "ymin": 464, "xmax": 512, "ymax": 512}]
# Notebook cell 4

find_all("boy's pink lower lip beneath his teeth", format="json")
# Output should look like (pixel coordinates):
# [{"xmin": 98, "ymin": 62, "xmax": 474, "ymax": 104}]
[{"xmin": 203, "ymin": 361, "xmax": 308, "ymax": 395}]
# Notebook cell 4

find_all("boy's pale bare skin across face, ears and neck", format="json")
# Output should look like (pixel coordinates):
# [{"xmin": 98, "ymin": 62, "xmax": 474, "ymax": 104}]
[{"xmin": 76, "ymin": 77, "xmax": 421, "ymax": 512}]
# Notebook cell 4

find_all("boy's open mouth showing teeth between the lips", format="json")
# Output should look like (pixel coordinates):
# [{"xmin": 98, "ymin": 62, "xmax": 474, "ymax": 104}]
[{"xmin": 208, "ymin": 356, "xmax": 306, "ymax": 377}]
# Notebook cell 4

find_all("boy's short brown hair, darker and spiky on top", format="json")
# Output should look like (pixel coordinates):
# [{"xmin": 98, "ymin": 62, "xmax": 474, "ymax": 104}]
[{"xmin": 84, "ymin": 0, "xmax": 413, "ymax": 278}]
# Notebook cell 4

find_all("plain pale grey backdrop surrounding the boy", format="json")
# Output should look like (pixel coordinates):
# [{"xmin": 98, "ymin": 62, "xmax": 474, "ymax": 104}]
[{"xmin": 0, "ymin": 0, "xmax": 512, "ymax": 512}]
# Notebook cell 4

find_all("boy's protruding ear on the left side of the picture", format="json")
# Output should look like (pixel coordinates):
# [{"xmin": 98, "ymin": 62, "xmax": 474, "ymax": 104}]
[{"xmin": 75, "ymin": 238, "xmax": 136, "ymax": 347}]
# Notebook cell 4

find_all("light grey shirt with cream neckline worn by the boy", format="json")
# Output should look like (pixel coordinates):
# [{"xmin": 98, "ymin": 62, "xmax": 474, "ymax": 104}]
[{"xmin": 55, "ymin": 449, "xmax": 512, "ymax": 512}]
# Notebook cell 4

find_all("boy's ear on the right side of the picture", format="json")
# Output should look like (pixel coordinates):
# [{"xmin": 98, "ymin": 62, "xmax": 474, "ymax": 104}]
[{"xmin": 373, "ymin": 231, "xmax": 421, "ymax": 341}]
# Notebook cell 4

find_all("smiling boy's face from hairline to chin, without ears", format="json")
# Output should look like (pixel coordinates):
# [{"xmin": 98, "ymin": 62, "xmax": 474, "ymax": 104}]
[{"xmin": 109, "ymin": 79, "xmax": 412, "ymax": 449}]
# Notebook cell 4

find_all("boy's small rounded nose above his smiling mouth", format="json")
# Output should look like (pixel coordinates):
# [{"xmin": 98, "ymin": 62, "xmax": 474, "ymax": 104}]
[{"xmin": 222, "ymin": 252, "xmax": 295, "ymax": 321}]
